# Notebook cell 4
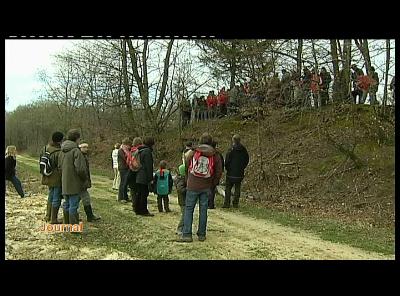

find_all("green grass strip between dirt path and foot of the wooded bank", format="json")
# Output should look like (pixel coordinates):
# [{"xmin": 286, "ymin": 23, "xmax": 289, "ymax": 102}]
[{"xmin": 217, "ymin": 195, "xmax": 395, "ymax": 255}]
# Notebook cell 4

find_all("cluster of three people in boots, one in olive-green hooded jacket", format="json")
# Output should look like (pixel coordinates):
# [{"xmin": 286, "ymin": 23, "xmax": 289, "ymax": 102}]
[{"xmin": 40, "ymin": 129, "xmax": 101, "ymax": 228}]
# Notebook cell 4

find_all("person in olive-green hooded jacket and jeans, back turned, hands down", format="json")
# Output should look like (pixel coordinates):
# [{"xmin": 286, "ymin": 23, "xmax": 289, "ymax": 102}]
[{"xmin": 58, "ymin": 129, "xmax": 88, "ymax": 228}]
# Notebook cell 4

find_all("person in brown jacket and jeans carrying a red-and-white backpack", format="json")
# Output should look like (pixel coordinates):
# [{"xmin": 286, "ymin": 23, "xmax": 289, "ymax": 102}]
[{"xmin": 177, "ymin": 133, "xmax": 222, "ymax": 242}]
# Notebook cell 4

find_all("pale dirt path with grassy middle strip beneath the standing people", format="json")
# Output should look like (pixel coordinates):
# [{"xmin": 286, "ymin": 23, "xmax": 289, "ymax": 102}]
[{"xmin": 6, "ymin": 156, "xmax": 394, "ymax": 259}]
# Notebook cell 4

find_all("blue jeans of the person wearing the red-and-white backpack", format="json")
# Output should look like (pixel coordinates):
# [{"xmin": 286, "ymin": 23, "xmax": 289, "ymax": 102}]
[{"xmin": 182, "ymin": 189, "xmax": 210, "ymax": 237}]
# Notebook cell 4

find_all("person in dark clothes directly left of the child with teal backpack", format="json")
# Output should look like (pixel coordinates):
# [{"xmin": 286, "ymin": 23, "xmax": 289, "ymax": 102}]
[{"xmin": 135, "ymin": 136, "xmax": 155, "ymax": 217}]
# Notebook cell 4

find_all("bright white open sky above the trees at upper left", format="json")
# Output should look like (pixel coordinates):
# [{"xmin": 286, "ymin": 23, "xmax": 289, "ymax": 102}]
[{"xmin": 5, "ymin": 39, "xmax": 76, "ymax": 111}]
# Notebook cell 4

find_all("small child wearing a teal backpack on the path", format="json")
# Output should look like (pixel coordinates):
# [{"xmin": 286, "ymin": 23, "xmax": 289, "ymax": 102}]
[{"xmin": 153, "ymin": 160, "xmax": 174, "ymax": 213}]
